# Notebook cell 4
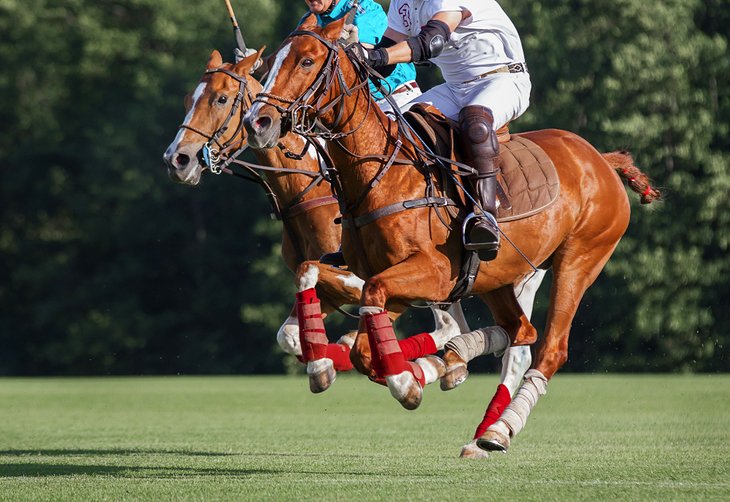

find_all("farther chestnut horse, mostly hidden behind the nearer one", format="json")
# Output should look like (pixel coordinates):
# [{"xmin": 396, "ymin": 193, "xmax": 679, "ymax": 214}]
[{"xmin": 164, "ymin": 45, "xmax": 542, "ymax": 456}]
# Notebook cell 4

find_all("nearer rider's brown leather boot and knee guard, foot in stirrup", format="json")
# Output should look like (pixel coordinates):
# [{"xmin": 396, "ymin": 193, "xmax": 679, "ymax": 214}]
[{"xmin": 459, "ymin": 105, "xmax": 501, "ymax": 261}]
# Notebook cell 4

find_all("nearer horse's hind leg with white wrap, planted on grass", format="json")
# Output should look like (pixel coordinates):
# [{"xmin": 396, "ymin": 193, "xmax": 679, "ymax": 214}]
[{"xmin": 477, "ymin": 237, "xmax": 623, "ymax": 451}]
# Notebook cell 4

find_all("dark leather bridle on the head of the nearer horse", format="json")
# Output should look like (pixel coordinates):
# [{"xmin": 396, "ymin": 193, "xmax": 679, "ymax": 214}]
[{"xmin": 254, "ymin": 30, "xmax": 367, "ymax": 139}]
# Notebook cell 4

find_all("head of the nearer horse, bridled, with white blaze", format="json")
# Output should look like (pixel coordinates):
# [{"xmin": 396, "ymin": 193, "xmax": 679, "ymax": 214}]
[{"xmin": 244, "ymin": 14, "xmax": 367, "ymax": 148}]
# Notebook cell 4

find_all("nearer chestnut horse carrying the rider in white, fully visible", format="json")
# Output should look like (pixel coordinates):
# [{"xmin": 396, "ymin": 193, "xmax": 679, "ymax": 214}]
[{"xmin": 244, "ymin": 16, "xmax": 658, "ymax": 451}]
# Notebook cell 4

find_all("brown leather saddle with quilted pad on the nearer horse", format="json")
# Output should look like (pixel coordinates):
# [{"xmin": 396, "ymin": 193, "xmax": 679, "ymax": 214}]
[{"xmin": 404, "ymin": 103, "xmax": 560, "ymax": 222}]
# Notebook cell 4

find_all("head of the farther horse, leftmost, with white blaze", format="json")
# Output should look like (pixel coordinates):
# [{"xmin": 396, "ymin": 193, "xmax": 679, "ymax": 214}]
[{"xmin": 163, "ymin": 48, "xmax": 264, "ymax": 185}]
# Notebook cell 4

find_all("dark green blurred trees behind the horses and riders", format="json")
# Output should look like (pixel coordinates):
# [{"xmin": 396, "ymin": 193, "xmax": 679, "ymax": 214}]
[{"xmin": 0, "ymin": 0, "xmax": 730, "ymax": 374}]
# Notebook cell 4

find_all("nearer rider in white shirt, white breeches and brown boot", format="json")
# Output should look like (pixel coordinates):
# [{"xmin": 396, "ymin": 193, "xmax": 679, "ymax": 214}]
[{"xmin": 354, "ymin": 0, "xmax": 532, "ymax": 260}]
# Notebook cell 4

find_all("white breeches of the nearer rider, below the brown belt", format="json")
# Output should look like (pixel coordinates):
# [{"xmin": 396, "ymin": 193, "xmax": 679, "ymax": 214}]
[{"xmin": 404, "ymin": 73, "xmax": 532, "ymax": 129}]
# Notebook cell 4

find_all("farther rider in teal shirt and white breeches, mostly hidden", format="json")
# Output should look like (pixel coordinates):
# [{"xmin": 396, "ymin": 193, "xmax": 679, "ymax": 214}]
[{"xmin": 304, "ymin": 0, "xmax": 421, "ymax": 112}]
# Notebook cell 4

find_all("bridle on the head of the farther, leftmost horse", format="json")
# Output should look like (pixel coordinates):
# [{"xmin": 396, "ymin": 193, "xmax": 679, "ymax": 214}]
[{"xmin": 179, "ymin": 68, "xmax": 253, "ymax": 174}]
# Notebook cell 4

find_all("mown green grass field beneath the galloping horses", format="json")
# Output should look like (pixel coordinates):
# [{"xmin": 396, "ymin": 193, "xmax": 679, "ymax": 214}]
[{"xmin": 0, "ymin": 375, "xmax": 730, "ymax": 501}]
